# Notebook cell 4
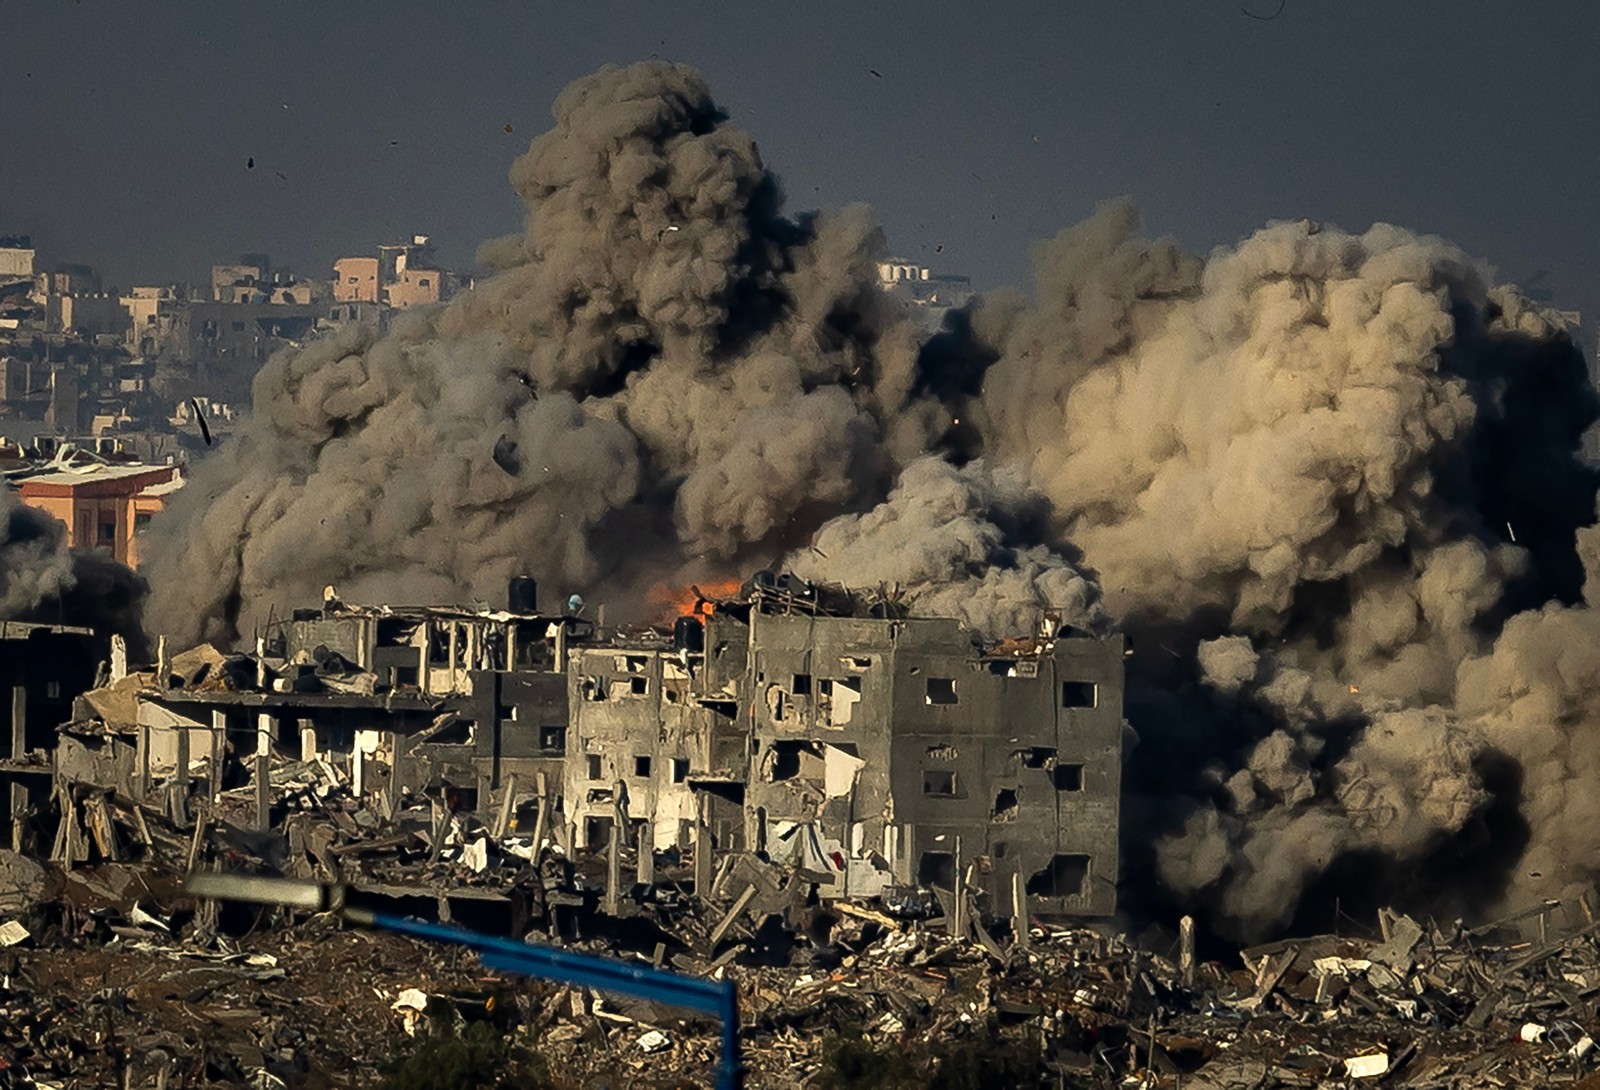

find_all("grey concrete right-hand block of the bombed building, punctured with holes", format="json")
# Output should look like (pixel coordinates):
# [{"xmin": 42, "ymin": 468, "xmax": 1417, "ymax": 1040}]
[{"xmin": 732, "ymin": 610, "xmax": 1123, "ymax": 916}]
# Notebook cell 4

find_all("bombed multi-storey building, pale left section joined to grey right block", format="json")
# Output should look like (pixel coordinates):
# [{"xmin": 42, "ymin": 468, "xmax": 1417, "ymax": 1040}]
[{"xmin": 565, "ymin": 573, "xmax": 1123, "ymax": 916}]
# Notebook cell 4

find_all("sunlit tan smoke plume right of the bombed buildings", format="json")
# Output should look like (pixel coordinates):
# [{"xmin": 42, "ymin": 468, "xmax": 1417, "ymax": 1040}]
[{"xmin": 938, "ymin": 205, "xmax": 1600, "ymax": 933}]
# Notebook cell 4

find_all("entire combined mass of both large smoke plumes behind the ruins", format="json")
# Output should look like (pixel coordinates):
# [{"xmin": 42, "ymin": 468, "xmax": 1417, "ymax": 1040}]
[{"xmin": 140, "ymin": 64, "xmax": 1600, "ymax": 933}]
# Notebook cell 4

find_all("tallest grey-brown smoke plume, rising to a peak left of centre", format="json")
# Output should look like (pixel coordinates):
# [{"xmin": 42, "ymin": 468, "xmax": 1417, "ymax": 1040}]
[{"xmin": 150, "ymin": 64, "xmax": 941, "ymax": 639}]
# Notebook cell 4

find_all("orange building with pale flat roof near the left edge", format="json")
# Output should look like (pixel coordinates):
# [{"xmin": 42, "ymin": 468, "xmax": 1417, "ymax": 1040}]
[{"xmin": 18, "ymin": 463, "xmax": 182, "ymax": 567}]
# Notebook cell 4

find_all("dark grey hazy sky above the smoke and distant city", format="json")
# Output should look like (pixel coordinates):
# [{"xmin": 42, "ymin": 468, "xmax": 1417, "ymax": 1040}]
[{"xmin": 0, "ymin": 0, "xmax": 1600, "ymax": 325}]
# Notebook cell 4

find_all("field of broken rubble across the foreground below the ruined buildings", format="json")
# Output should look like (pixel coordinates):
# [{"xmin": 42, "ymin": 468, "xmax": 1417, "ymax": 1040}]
[{"xmin": 0, "ymin": 836, "xmax": 1600, "ymax": 1090}]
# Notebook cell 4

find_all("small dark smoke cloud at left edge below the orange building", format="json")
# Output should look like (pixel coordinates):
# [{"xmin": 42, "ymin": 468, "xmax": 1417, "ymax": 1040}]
[{"xmin": 0, "ymin": 488, "xmax": 147, "ymax": 646}]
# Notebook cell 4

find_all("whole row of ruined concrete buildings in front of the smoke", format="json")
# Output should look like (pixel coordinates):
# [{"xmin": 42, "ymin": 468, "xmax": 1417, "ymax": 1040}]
[{"xmin": 78, "ymin": 573, "xmax": 1123, "ymax": 917}]
